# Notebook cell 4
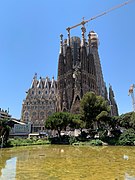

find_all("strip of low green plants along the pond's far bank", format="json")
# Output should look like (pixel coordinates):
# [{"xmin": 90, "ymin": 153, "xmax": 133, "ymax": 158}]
[{"xmin": 6, "ymin": 130, "xmax": 135, "ymax": 147}]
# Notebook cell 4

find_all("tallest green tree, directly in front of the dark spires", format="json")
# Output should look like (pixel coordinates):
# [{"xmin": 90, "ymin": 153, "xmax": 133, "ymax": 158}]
[{"xmin": 81, "ymin": 92, "xmax": 110, "ymax": 129}]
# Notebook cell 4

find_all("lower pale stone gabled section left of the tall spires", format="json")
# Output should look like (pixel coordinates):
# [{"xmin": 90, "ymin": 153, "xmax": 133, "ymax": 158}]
[{"xmin": 21, "ymin": 74, "xmax": 57, "ymax": 132}]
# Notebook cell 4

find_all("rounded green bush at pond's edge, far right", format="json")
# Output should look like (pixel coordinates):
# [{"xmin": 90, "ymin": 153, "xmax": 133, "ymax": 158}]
[{"xmin": 117, "ymin": 129, "xmax": 135, "ymax": 146}]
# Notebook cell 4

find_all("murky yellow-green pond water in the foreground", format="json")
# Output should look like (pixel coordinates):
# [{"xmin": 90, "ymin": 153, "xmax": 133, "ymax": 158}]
[{"xmin": 0, "ymin": 145, "xmax": 135, "ymax": 180}]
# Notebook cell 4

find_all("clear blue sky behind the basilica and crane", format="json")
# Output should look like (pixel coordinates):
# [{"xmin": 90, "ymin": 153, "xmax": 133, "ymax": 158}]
[{"xmin": 0, "ymin": 0, "xmax": 135, "ymax": 118}]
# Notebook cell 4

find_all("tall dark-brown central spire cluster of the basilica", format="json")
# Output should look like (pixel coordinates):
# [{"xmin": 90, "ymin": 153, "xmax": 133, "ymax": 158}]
[{"xmin": 57, "ymin": 30, "xmax": 106, "ymax": 113}]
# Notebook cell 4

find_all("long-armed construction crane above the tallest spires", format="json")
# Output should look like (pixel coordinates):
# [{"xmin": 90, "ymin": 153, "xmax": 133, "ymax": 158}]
[{"xmin": 66, "ymin": 0, "xmax": 134, "ymax": 39}]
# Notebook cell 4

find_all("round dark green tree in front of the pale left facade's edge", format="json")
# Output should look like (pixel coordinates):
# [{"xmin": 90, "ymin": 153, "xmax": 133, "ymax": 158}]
[{"xmin": 45, "ymin": 112, "xmax": 71, "ymax": 137}]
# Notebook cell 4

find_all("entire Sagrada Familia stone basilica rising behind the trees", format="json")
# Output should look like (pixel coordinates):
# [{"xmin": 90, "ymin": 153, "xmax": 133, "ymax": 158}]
[{"xmin": 21, "ymin": 27, "xmax": 118, "ymax": 132}]
